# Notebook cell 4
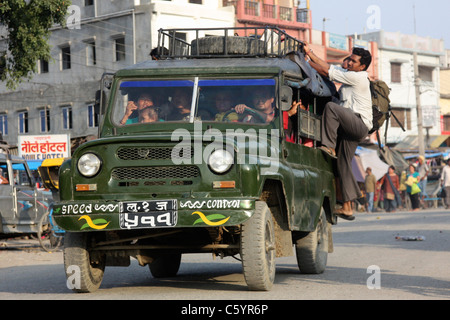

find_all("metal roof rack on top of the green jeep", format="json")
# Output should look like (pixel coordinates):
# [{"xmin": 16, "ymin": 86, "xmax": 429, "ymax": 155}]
[{"xmin": 156, "ymin": 26, "xmax": 303, "ymax": 59}]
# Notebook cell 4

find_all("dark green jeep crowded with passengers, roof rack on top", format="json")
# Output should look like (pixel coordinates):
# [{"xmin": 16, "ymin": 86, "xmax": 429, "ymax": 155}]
[{"xmin": 53, "ymin": 27, "xmax": 336, "ymax": 292}]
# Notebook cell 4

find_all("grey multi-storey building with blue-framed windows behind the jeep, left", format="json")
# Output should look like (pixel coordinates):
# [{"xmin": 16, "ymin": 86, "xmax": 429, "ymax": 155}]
[{"xmin": 0, "ymin": 0, "xmax": 235, "ymax": 147}]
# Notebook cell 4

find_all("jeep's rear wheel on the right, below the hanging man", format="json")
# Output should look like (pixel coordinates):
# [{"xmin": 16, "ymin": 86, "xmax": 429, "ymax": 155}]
[{"xmin": 295, "ymin": 208, "xmax": 328, "ymax": 274}]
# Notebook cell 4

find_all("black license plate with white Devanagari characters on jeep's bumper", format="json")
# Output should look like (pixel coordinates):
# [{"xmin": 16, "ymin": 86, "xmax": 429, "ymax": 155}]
[{"xmin": 119, "ymin": 200, "xmax": 178, "ymax": 229}]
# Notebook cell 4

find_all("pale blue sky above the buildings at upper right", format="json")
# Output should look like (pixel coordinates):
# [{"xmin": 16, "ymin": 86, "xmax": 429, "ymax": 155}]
[{"xmin": 310, "ymin": 0, "xmax": 450, "ymax": 49}]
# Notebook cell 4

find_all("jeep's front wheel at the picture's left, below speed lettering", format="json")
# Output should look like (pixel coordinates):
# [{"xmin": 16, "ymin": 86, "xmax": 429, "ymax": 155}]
[{"xmin": 64, "ymin": 232, "xmax": 105, "ymax": 293}]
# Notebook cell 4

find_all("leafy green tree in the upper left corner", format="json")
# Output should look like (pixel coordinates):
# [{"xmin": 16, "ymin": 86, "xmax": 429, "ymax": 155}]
[{"xmin": 0, "ymin": 0, "xmax": 71, "ymax": 89}]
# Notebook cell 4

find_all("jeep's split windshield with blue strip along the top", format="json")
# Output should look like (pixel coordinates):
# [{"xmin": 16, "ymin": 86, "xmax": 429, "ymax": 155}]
[{"xmin": 113, "ymin": 78, "xmax": 276, "ymax": 126}]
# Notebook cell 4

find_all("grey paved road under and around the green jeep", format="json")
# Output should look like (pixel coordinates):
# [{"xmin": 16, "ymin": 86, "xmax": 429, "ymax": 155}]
[{"xmin": 0, "ymin": 210, "xmax": 450, "ymax": 301}]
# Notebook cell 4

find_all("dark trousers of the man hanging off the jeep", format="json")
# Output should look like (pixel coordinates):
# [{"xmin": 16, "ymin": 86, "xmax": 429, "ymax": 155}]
[{"xmin": 322, "ymin": 102, "xmax": 369, "ymax": 202}]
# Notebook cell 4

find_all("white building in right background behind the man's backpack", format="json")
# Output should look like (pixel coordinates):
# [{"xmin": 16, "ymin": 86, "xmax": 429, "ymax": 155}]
[{"xmin": 359, "ymin": 30, "xmax": 445, "ymax": 150}]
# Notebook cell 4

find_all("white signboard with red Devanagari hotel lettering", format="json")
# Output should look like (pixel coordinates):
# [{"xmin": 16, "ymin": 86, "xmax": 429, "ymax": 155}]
[{"xmin": 19, "ymin": 134, "xmax": 70, "ymax": 160}]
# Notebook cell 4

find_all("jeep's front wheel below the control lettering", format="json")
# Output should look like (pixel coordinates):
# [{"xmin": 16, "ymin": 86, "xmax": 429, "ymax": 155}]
[{"xmin": 241, "ymin": 201, "xmax": 275, "ymax": 291}]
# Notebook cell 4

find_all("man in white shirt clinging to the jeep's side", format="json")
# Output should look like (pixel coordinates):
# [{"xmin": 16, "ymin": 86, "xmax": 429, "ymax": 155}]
[{"xmin": 304, "ymin": 43, "xmax": 372, "ymax": 220}]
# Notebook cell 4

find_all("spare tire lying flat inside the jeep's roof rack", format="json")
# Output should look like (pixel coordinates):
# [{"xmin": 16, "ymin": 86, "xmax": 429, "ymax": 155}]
[{"xmin": 191, "ymin": 36, "xmax": 265, "ymax": 56}]
